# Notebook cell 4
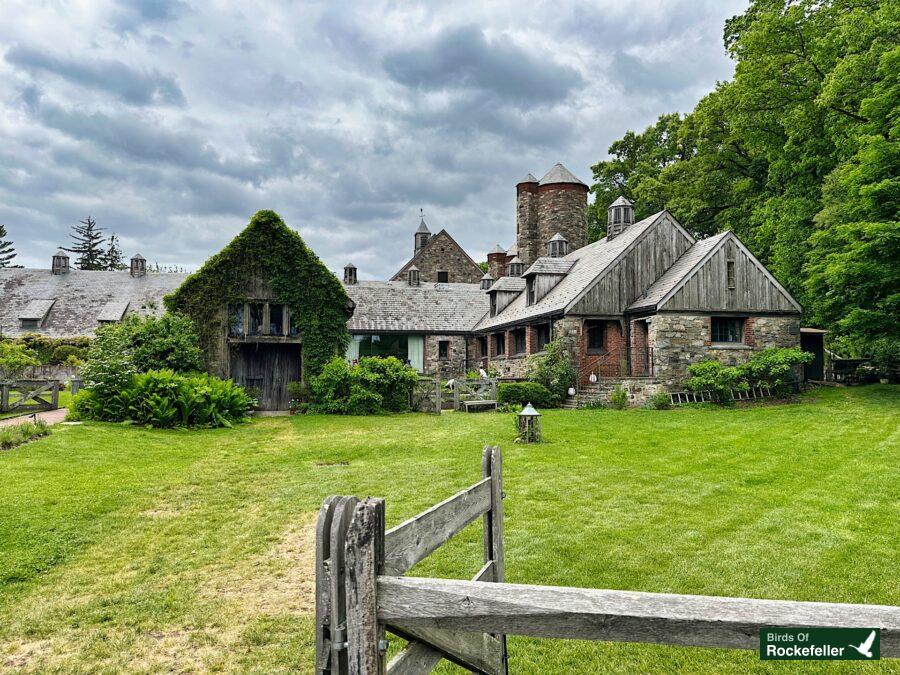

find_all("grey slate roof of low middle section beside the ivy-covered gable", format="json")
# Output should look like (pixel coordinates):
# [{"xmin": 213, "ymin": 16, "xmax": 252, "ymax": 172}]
[{"xmin": 344, "ymin": 281, "xmax": 489, "ymax": 333}]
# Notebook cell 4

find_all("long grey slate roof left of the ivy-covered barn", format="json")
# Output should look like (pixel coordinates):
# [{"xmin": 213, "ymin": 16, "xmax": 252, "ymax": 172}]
[{"xmin": 0, "ymin": 268, "xmax": 188, "ymax": 337}]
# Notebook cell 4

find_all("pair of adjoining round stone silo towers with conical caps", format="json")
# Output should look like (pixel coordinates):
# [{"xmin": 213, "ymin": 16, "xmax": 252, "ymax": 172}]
[{"xmin": 516, "ymin": 164, "xmax": 588, "ymax": 268}]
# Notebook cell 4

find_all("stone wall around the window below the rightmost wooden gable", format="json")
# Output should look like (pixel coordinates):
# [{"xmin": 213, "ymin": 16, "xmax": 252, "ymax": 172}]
[{"xmin": 649, "ymin": 313, "xmax": 800, "ymax": 389}]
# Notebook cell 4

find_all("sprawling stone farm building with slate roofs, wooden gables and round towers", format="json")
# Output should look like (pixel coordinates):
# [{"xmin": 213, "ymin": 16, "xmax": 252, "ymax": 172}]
[{"xmin": 0, "ymin": 164, "xmax": 801, "ymax": 400}]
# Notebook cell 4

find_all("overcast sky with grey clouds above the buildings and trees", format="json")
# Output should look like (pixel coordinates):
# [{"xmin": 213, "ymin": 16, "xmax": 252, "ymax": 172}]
[{"xmin": 0, "ymin": 0, "xmax": 746, "ymax": 278}]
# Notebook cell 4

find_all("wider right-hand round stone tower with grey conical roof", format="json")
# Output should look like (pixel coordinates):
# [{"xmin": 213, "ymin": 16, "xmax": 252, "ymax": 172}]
[{"xmin": 536, "ymin": 164, "xmax": 588, "ymax": 264}]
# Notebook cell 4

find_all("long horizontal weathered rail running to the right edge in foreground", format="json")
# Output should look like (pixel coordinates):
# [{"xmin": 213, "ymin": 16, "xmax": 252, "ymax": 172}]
[{"xmin": 377, "ymin": 577, "xmax": 900, "ymax": 657}]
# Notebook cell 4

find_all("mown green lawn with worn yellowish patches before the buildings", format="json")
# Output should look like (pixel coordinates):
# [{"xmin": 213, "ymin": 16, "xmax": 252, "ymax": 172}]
[{"xmin": 0, "ymin": 385, "xmax": 900, "ymax": 673}]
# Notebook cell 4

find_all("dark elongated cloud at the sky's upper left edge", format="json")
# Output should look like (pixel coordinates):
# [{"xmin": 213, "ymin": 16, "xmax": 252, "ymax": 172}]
[{"xmin": 5, "ymin": 45, "xmax": 185, "ymax": 106}]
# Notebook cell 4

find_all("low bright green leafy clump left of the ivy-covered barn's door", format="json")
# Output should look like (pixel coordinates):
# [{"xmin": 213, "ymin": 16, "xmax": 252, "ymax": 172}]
[{"xmin": 69, "ymin": 370, "xmax": 254, "ymax": 429}]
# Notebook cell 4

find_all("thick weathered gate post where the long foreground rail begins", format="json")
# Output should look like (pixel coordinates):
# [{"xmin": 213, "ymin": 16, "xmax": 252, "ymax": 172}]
[{"xmin": 344, "ymin": 497, "xmax": 385, "ymax": 675}]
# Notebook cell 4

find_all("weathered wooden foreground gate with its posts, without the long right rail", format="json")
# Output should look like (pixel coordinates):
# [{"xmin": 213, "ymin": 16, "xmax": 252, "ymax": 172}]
[{"xmin": 316, "ymin": 447, "xmax": 507, "ymax": 675}]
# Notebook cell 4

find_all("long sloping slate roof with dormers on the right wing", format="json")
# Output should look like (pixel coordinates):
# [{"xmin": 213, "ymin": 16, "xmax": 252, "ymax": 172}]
[{"xmin": 475, "ymin": 211, "xmax": 684, "ymax": 330}]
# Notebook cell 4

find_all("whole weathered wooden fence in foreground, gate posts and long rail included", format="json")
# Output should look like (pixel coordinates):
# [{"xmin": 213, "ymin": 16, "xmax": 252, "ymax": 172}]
[{"xmin": 316, "ymin": 447, "xmax": 900, "ymax": 675}]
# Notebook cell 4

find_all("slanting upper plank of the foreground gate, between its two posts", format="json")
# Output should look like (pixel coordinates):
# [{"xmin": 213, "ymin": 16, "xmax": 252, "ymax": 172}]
[{"xmin": 384, "ymin": 478, "xmax": 491, "ymax": 575}]
